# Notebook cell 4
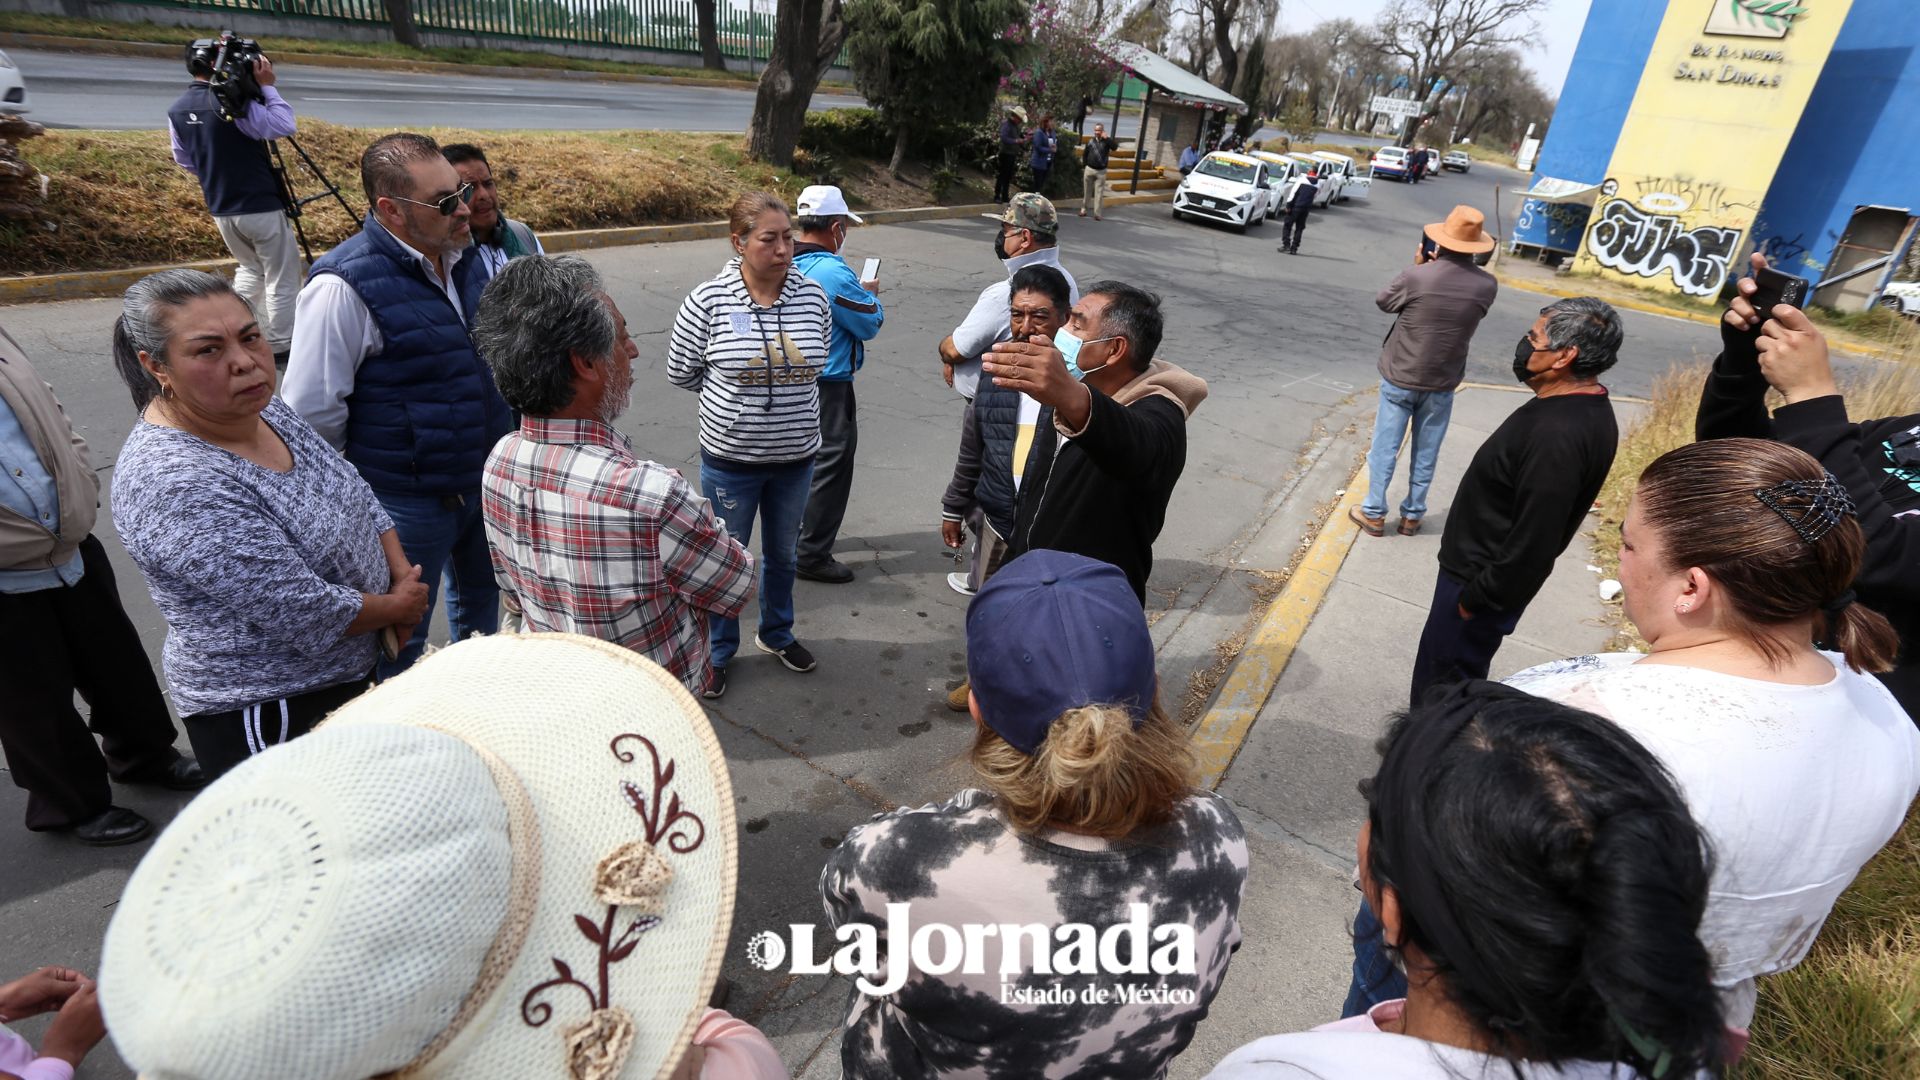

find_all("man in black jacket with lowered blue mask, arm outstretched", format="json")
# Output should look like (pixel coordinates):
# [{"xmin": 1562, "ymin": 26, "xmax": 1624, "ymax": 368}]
[{"xmin": 981, "ymin": 281, "xmax": 1206, "ymax": 603}]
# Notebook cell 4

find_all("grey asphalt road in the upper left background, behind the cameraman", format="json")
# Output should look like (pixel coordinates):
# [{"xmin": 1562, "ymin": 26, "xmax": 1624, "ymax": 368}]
[{"xmin": 8, "ymin": 48, "xmax": 862, "ymax": 131}]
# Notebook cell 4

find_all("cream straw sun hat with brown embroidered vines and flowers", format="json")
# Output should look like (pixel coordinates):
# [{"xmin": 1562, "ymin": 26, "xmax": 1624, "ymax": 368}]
[{"xmin": 100, "ymin": 634, "xmax": 737, "ymax": 1080}]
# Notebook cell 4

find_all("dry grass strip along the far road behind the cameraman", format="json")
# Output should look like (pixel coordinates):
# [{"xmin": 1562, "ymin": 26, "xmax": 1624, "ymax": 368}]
[{"xmin": 0, "ymin": 119, "xmax": 956, "ymax": 273}]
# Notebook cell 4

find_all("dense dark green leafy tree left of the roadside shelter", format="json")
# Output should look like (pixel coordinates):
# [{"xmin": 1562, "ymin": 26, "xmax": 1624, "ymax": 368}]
[{"xmin": 844, "ymin": 0, "xmax": 1027, "ymax": 175}]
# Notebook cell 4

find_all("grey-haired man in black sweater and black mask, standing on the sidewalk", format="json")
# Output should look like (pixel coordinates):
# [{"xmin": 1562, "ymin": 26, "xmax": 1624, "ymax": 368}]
[{"xmin": 1413, "ymin": 296, "xmax": 1624, "ymax": 705}]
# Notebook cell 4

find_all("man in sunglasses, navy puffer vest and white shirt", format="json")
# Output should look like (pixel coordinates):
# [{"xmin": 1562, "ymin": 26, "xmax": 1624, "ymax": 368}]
[{"xmin": 282, "ymin": 133, "xmax": 515, "ymax": 678}]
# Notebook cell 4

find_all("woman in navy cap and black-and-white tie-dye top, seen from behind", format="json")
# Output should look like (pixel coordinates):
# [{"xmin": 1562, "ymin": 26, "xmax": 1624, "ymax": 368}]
[{"xmin": 820, "ymin": 550, "xmax": 1248, "ymax": 1080}]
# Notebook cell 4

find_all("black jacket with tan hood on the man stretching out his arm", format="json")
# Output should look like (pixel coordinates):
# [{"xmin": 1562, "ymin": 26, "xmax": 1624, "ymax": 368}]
[{"xmin": 1008, "ymin": 361, "xmax": 1206, "ymax": 603}]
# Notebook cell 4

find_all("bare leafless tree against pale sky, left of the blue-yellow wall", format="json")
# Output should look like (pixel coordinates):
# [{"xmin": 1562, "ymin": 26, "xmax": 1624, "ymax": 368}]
[{"xmin": 1375, "ymin": 0, "xmax": 1548, "ymax": 144}]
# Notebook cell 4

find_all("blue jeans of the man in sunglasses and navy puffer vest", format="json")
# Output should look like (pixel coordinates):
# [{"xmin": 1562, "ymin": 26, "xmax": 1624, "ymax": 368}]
[{"xmin": 374, "ymin": 488, "xmax": 499, "ymax": 678}]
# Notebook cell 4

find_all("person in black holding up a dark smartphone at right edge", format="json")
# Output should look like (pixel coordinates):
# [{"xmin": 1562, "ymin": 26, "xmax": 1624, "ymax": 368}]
[{"xmin": 1693, "ymin": 254, "xmax": 1920, "ymax": 723}]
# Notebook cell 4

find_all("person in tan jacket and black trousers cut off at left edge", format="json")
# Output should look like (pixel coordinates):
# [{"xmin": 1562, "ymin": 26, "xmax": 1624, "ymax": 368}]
[{"xmin": 0, "ymin": 322, "xmax": 205, "ymax": 846}]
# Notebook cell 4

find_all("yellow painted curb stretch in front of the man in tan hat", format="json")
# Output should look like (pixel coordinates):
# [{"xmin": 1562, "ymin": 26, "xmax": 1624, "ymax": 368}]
[{"xmin": 1192, "ymin": 457, "xmax": 1367, "ymax": 788}]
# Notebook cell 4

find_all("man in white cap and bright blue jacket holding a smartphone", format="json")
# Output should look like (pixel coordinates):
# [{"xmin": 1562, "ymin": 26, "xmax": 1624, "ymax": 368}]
[{"xmin": 793, "ymin": 184, "xmax": 887, "ymax": 584}]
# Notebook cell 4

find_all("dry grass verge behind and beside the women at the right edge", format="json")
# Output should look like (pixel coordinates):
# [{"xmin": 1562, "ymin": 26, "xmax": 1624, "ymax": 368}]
[{"xmin": 1594, "ymin": 350, "xmax": 1920, "ymax": 1080}]
